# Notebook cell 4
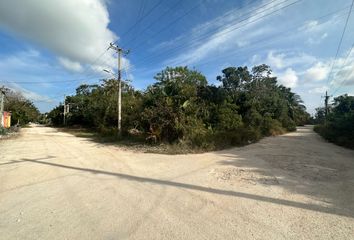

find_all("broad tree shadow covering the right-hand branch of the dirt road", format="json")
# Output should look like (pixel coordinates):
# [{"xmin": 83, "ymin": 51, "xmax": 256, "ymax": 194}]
[{"xmin": 217, "ymin": 127, "xmax": 354, "ymax": 217}]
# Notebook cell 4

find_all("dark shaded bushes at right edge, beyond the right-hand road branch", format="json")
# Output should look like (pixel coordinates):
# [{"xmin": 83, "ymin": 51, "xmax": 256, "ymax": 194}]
[{"xmin": 315, "ymin": 95, "xmax": 354, "ymax": 149}]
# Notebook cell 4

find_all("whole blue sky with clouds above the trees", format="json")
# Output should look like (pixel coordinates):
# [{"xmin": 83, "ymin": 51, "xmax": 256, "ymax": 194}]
[{"xmin": 0, "ymin": 0, "xmax": 354, "ymax": 113}]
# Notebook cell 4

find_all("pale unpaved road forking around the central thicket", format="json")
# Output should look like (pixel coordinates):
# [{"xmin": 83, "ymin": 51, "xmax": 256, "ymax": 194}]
[{"xmin": 0, "ymin": 126, "xmax": 354, "ymax": 240}]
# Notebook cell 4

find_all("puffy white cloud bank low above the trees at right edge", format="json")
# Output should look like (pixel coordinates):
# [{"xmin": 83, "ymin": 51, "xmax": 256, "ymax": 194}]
[{"xmin": 249, "ymin": 49, "xmax": 354, "ymax": 94}]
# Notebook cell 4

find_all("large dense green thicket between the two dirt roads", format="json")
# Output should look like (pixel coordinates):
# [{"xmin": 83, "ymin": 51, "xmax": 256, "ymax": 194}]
[{"xmin": 48, "ymin": 65, "xmax": 309, "ymax": 148}]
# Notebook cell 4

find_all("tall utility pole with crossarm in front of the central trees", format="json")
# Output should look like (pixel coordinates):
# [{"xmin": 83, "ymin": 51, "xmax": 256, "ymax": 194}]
[{"xmin": 108, "ymin": 43, "xmax": 129, "ymax": 136}]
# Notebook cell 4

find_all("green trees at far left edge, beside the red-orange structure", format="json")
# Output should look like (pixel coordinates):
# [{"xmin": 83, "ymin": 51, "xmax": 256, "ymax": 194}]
[{"xmin": 4, "ymin": 89, "xmax": 41, "ymax": 125}]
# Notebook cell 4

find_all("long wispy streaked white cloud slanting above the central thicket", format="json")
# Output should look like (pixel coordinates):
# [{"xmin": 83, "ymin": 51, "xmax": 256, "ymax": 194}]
[{"xmin": 161, "ymin": 0, "xmax": 284, "ymax": 65}]
